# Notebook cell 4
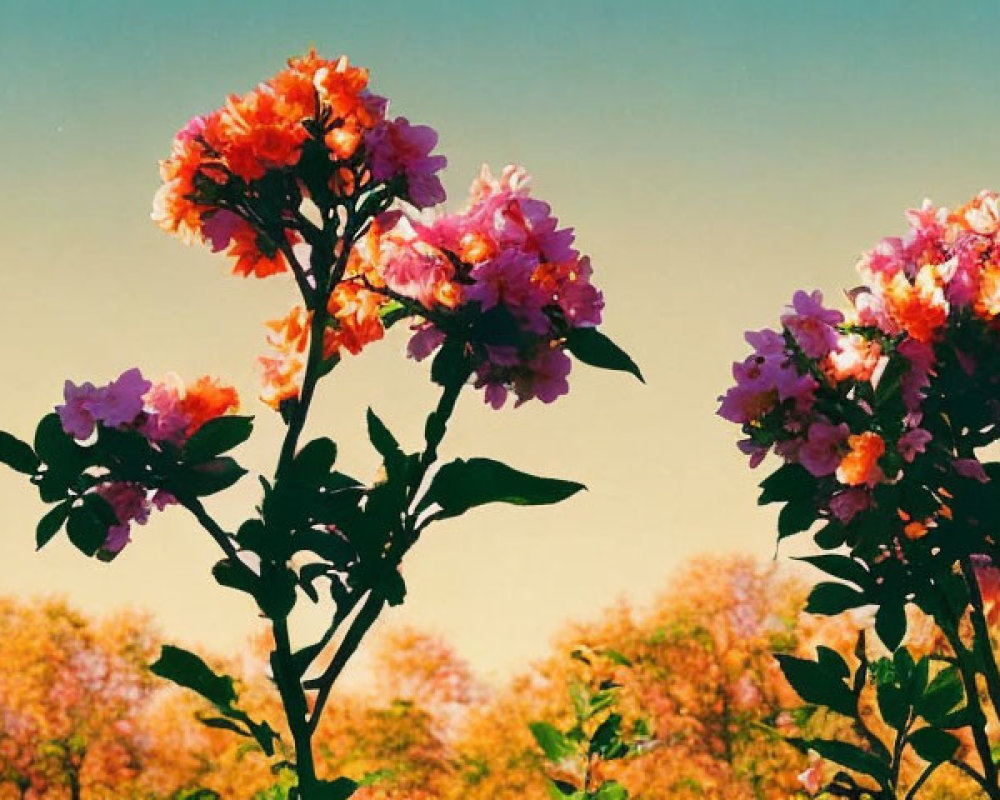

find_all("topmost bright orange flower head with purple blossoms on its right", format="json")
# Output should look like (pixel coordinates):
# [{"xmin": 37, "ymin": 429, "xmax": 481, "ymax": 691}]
[{"xmin": 153, "ymin": 52, "xmax": 445, "ymax": 278}]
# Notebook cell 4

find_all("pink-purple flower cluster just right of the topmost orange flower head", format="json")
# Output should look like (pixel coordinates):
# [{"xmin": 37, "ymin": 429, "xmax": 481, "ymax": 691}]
[{"xmin": 377, "ymin": 166, "xmax": 604, "ymax": 408}]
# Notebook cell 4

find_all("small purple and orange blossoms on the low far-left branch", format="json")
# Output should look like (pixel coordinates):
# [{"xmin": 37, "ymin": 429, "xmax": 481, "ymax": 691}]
[{"xmin": 56, "ymin": 368, "xmax": 239, "ymax": 558}]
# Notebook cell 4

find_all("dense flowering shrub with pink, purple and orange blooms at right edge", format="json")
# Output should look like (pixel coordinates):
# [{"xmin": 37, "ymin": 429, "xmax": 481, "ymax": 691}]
[{"xmin": 719, "ymin": 191, "xmax": 1000, "ymax": 798}]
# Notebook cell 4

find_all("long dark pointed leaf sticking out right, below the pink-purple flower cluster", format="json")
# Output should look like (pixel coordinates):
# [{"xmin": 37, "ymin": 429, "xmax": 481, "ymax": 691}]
[{"xmin": 420, "ymin": 458, "xmax": 586, "ymax": 519}]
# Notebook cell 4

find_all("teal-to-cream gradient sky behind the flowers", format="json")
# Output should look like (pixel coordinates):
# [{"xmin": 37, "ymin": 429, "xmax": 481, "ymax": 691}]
[{"xmin": 0, "ymin": 0, "xmax": 1000, "ymax": 675}]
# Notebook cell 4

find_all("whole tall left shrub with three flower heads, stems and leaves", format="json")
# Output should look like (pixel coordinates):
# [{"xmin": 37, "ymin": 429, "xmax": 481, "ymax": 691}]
[{"xmin": 0, "ymin": 52, "xmax": 641, "ymax": 800}]
